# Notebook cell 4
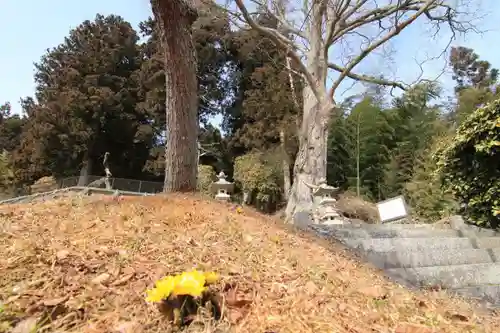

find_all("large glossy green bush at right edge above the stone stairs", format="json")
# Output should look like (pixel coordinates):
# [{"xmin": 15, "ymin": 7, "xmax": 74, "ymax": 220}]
[{"xmin": 436, "ymin": 99, "xmax": 500, "ymax": 228}]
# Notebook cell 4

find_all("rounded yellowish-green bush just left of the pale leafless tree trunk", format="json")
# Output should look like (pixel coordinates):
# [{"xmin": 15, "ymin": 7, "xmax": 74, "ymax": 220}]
[{"xmin": 234, "ymin": 152, "xmax": 283, "ymax": 212}]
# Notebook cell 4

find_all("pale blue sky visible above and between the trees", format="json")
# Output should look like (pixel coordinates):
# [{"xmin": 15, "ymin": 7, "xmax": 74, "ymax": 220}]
[{"xmin": 0, "ymin": 0, "xmax": 500, "ymax": 113}]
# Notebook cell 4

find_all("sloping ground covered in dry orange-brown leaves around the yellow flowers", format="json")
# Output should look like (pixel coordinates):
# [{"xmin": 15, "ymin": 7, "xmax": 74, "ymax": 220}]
[{"xmin": 0, "ymin": 196, "xmax": 500, "ymax": 333}]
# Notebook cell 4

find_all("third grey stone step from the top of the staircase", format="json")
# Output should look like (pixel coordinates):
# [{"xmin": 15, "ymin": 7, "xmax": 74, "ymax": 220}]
[{"xmin": 364, "ymin": 248, "xmax": 500, "ymax": 269}]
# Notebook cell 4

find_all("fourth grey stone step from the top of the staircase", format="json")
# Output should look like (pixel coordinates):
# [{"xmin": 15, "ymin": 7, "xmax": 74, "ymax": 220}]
[{"xmin": 386, "ymin": 263, "xmax": 500, "ymax": 289}]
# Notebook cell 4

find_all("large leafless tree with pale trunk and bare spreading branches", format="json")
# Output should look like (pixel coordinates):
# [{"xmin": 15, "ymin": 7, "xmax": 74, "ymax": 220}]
[{"xmin": 226, "ymin": 0, "xmax": 474, "ymax": 221}]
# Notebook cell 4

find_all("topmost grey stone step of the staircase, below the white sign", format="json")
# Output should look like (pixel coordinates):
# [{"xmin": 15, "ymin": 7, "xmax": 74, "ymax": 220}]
[{"xmin": 315, "ymin": 225, "xmax": 460, "ymax": 238}]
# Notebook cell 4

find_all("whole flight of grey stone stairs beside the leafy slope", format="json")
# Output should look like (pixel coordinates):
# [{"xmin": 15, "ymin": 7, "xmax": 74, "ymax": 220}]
[{"xmin": 312, "ymin": 216, "xmax": 500, "ymax": 307}]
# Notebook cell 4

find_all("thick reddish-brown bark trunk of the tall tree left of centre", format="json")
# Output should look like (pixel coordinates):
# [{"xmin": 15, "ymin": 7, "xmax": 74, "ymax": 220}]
[{"xmin": 151, "ymin": 0, "xmax": 198, "ymax": 192}]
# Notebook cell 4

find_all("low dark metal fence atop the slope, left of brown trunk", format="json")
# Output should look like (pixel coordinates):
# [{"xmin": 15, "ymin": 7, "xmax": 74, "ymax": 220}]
[{"xmin": 58, "ymin": 176, "xmax": 163, "ymax": 193}]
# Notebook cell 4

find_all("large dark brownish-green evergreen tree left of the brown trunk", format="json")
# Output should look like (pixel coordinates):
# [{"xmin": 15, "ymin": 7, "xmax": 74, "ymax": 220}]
[{"xmin": 17, "ymin": 15, "xmax": 151, "ymax": 182}]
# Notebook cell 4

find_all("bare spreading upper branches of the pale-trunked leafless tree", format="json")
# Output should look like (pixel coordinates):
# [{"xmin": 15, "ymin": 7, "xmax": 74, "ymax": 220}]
[{"xmin": 234, "ymin": 0, "xmax": 474, "ymax": 103}]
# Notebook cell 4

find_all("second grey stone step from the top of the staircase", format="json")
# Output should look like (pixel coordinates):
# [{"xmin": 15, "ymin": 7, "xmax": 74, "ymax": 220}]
[{"xmin": 339, "ymin": 237, "xmax": 473, "ymax": 252}]
